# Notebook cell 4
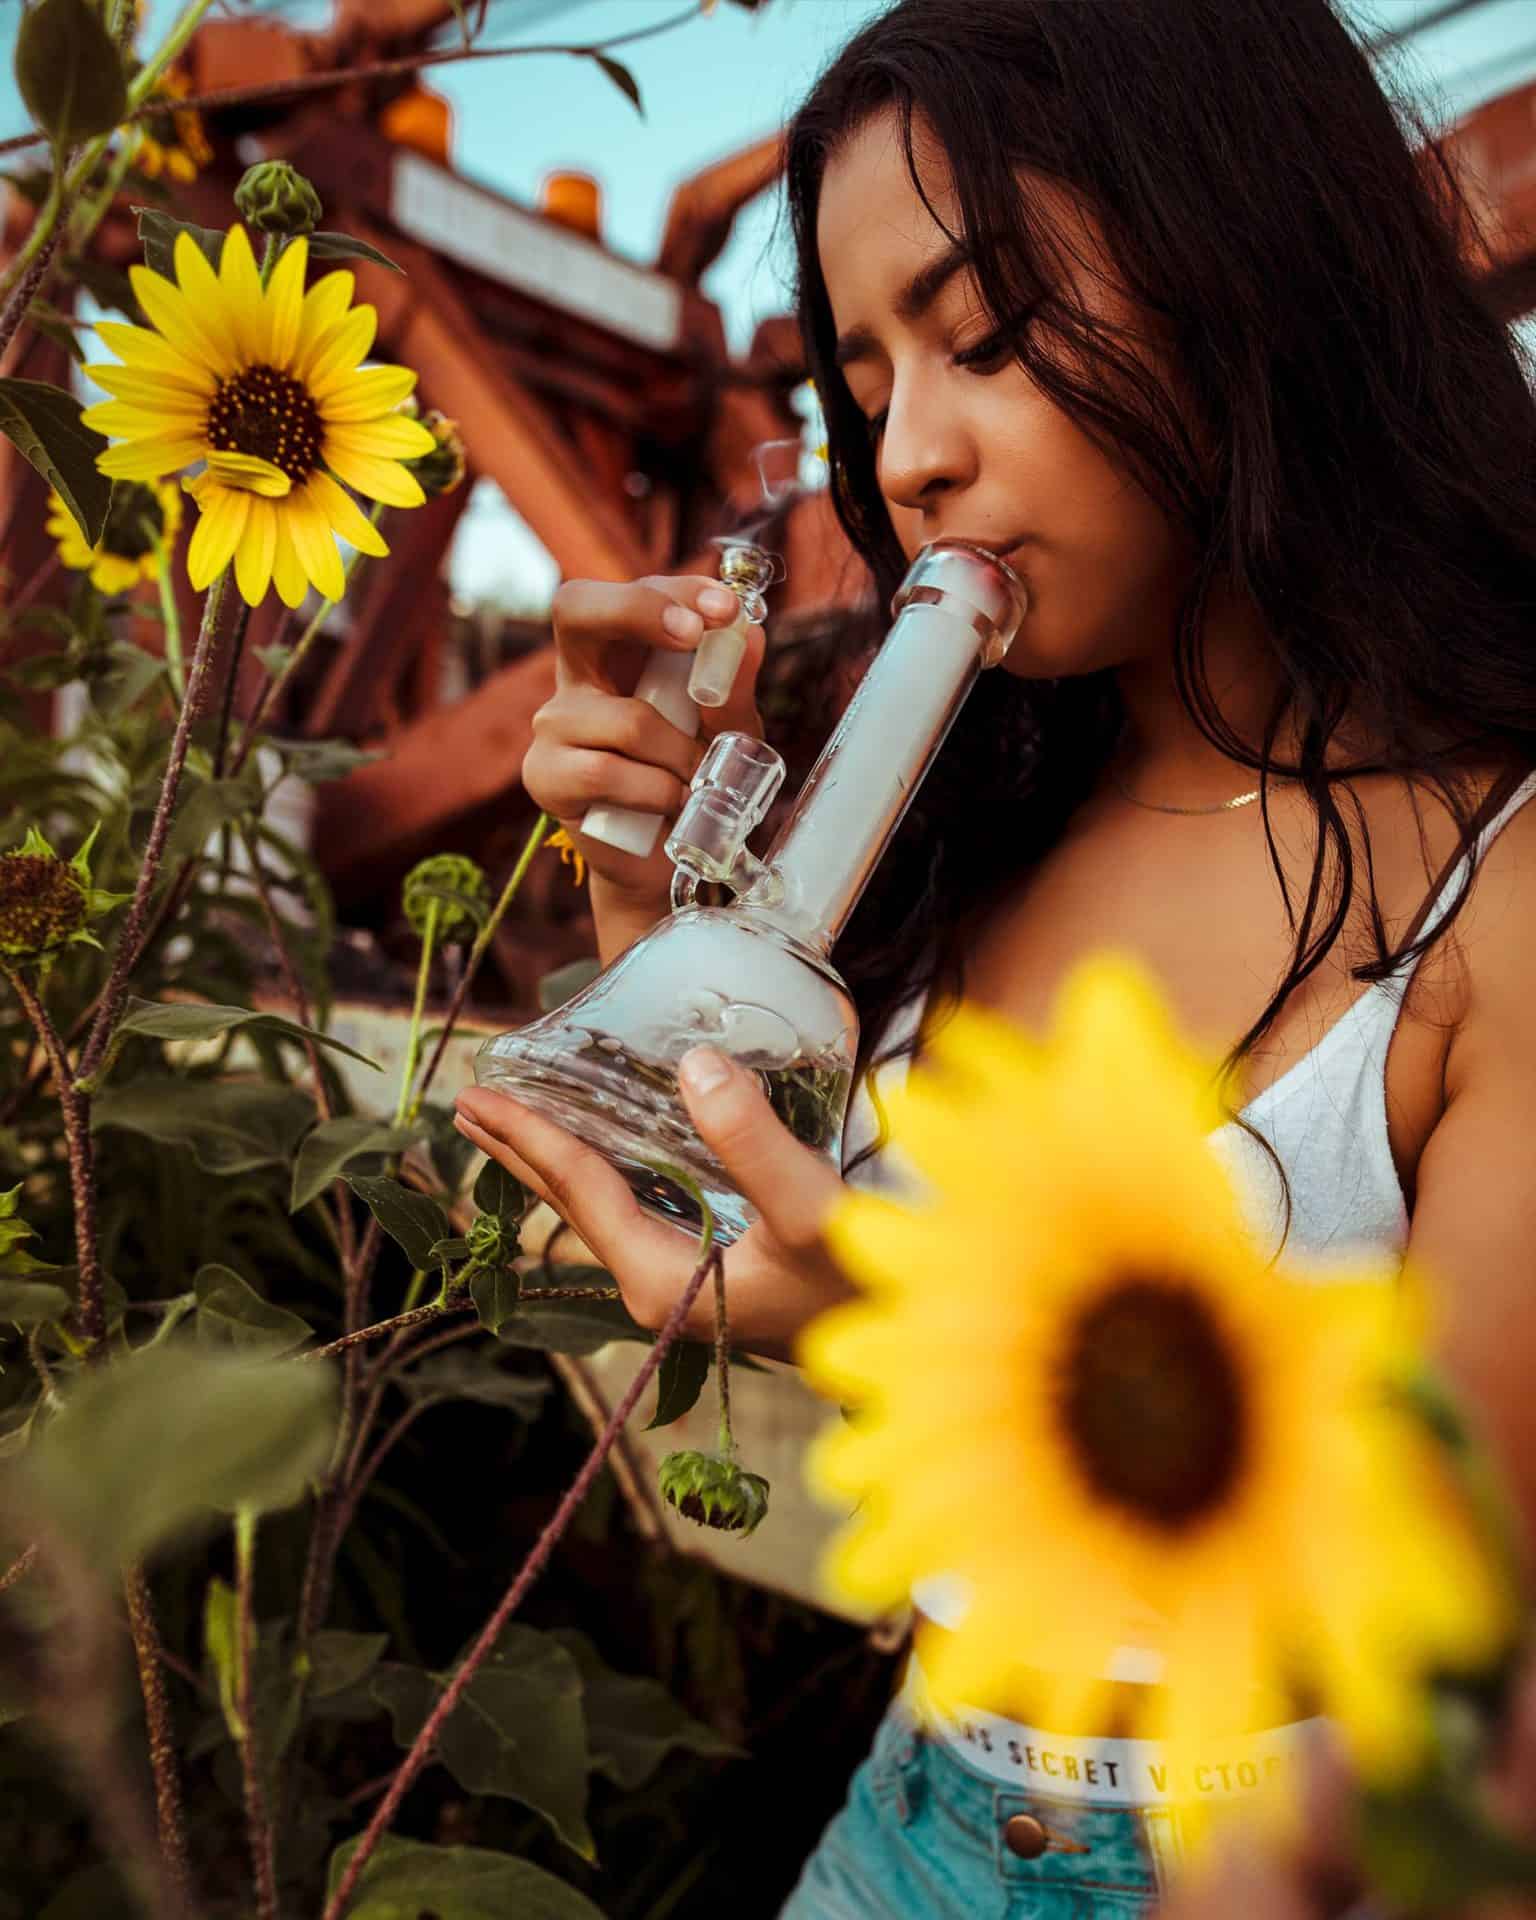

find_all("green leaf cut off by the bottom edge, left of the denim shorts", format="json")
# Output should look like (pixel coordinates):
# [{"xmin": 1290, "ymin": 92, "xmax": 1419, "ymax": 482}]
[{"xmin": 328, "ymin": 1834, "xmax": 603, "ymax": 1920}]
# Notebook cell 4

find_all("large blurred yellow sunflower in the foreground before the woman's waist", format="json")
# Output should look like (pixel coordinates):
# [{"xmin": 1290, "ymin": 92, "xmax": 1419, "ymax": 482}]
[{"xmin": 799, "ymin": 956, "xmax": 1511, "ymax": 1803}]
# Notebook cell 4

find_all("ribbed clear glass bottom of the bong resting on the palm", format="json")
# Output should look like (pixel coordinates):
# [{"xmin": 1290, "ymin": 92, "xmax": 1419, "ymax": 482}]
[{"xmin": 474, "ymin": 1035, "xmax": 756, "ymax": 1246}]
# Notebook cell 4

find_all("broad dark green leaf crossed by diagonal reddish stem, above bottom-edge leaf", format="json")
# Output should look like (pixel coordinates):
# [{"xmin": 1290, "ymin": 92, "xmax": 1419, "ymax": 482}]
[{"xmin": 371, "ymin": 1624, "xmax": 597, "ymax": 1860}]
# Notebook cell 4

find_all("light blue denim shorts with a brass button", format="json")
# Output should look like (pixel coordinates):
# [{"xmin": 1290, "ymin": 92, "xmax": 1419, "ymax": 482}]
[{"xmin": 780, "ymin": 1699, "xmax": 1177, "ymax": 1920}]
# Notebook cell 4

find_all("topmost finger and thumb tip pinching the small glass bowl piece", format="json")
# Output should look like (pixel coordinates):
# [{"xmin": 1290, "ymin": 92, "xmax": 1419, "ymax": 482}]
[{"xmin": 551, "ymin": 574, "xmax": 737, "ymax": 693}]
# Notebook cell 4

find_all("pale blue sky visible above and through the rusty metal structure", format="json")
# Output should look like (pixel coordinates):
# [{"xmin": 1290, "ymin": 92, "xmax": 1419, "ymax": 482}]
[{"xmin": 0, "ymin": 0, "xmax": 1536, "ymax": 603}]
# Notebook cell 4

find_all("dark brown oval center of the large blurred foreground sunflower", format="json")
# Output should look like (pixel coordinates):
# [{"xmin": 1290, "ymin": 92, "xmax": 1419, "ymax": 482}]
[{"xmin": 1058, "ymin": 1281, "xmax": 1246, "ymax": 1532}]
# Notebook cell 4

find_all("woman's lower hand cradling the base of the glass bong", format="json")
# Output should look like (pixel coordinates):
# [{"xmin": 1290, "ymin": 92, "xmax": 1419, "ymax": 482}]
[{"xmin": 455, "ymin": 1046, "xmax": 854, "ymax": 1359}]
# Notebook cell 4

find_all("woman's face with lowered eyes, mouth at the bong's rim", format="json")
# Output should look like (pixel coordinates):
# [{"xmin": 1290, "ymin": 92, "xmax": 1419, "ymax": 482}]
[{"xmin": 816, "ymin": 111, "xmax": 1192, "ymax": 680}]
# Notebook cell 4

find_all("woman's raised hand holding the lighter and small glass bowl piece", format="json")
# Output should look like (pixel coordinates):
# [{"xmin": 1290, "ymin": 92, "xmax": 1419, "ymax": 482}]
[{"xmin": 522, "ymin": 574, "xmax": 762, "ymax": 940}]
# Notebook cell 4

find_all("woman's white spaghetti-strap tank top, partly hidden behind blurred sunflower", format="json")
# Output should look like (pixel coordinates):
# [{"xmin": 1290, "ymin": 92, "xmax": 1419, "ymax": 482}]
[{"xmin": 843, "ymin": 774, "xmax": 1536, "ymax": 1643}]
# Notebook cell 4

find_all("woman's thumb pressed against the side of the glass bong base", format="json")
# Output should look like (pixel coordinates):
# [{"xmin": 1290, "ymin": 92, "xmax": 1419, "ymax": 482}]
[{"xmin": 678, "ymin": 1046, "xmax": 843, "ymax": 1252}]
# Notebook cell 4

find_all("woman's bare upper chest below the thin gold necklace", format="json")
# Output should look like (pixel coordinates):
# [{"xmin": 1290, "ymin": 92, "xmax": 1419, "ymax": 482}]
[{"xmin": 962, "ymin": 787, "xmax": 1459, "ymax": 1206}]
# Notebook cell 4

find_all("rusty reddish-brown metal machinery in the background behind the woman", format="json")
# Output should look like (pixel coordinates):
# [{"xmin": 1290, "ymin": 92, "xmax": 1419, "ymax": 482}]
[{"xmin": 0, "ymin": 0, "xmax": 1536, "ymax": 990}]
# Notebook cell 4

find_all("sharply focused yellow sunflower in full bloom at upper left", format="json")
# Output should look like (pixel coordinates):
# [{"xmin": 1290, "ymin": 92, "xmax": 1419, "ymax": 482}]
[{"xmin": 81, "ymin": 227, "xmax": 436, "ymax": 607}]
